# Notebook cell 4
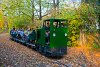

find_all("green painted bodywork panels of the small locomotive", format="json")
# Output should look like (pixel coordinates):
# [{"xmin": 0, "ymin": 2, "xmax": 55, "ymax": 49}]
[{"xmin": 36, "ymin": 18, "xmax": 68, "ymax": 48}]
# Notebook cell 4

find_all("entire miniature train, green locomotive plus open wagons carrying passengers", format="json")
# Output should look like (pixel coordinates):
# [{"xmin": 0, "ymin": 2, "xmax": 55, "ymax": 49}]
[{"xmin": 10, "ymin": 18, "xmax": 68, "ymax": 56}]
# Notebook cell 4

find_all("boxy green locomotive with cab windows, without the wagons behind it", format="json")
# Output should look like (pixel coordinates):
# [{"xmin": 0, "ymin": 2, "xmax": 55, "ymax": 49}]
[{"xmin": 36, "ymin": 19, "xmax": 68, "ymax": 55}]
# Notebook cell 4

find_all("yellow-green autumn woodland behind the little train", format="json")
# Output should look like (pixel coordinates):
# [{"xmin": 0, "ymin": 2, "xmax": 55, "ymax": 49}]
[{"xmin": 0, "ymin": 0, "xmax": 100, "ymax": 50}]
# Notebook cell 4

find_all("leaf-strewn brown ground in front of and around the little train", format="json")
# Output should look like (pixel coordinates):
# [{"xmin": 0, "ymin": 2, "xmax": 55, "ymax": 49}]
[{"xmin": 0, "ymin": 33, "xmax": 100, "ymax": 67}]
